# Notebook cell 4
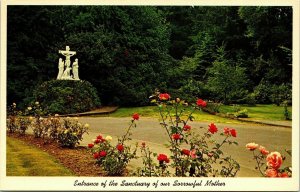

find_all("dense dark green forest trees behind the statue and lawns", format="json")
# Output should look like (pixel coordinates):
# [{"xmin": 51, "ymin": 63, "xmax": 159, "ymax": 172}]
[{"xmin": 7, "ymin": 6, "xmax": 292, "ymax": 106}]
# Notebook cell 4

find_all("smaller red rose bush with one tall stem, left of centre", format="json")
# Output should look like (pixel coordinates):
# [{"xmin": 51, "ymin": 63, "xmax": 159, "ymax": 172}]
[{"xmin": 88, "ymin": 113, "xmax": 139, "ymax": 176}]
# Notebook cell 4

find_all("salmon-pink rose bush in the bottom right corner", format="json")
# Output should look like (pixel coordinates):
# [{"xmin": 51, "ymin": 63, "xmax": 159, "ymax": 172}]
[{"xmin": 246, "ymin": 143, "xmax": 292, "ymax": 177}]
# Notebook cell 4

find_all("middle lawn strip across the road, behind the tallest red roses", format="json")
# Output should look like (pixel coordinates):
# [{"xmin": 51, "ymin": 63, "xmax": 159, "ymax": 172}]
[{"xmin": 109, "ymin": 106, "xmax": 243, "ymax": 124}]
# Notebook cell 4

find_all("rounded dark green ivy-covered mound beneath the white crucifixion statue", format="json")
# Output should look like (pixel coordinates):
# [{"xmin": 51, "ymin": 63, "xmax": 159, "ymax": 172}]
[{"xmin": 33, "ymin": 80, "xmax": 100, "ymax": 114}]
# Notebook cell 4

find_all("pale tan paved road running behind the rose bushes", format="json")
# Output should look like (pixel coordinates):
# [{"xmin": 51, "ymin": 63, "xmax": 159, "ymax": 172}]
[{"xmin": 79, "ymin": 117, "xmax": 292, "ymax": 177}]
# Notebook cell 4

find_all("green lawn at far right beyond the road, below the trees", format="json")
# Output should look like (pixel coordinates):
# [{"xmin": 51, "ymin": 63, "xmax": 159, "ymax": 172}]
[{"xmin": 220, "ymin": 104, "xmax": 292, "ymax": 121}]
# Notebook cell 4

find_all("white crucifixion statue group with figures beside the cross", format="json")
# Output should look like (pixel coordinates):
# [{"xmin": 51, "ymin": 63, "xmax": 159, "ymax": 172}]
[{"xmin": 57, "ymin": 46, "xmax": 80, "ymax": 80}]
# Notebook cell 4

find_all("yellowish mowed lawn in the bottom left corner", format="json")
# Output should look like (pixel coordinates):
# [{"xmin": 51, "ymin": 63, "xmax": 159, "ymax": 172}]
[{"xmin": 6, "ymin": 137, "xmax": 74, "ymax": 176}]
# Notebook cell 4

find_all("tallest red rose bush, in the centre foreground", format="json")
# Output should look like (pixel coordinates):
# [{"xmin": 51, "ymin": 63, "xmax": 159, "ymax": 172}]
[{"xmin": 144, "ymin": 93, "xmax": 240, "ymax": 177}]
